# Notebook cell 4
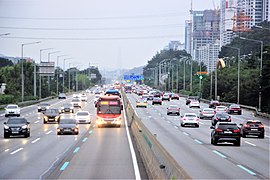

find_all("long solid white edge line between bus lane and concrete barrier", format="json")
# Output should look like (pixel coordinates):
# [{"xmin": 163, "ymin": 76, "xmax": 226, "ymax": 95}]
[{"xmin": 123, "ymin": 100, "xmax": 141, "ymax": 180}]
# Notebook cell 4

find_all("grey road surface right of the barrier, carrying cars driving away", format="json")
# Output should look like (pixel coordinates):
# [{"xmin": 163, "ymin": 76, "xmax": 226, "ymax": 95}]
[{"xmin": 128, "ymin": 94, "xmax": 270, "ymax": 179}]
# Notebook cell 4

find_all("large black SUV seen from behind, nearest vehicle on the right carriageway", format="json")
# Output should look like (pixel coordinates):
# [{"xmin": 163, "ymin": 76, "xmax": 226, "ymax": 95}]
[{"xmin": 210, "ymin": 122, "xmax": 241, "ymax": 146}]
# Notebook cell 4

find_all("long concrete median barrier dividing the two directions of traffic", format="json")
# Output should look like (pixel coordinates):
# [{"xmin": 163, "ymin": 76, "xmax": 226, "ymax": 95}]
[{"xmin": 122, "ymin": 93, "xmax": 191, "ymax": 179}]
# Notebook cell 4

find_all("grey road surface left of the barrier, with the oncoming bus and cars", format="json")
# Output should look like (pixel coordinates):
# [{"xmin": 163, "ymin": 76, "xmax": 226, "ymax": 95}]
[{"xmin": 0, "ymin": 95, "xmax": 140, "ymax": 179}]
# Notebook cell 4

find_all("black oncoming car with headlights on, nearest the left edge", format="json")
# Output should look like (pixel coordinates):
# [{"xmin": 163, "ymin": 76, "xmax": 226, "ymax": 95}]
[{"xmin": 4, "ymin": 117, "xmax": 30, "ymax": 138}]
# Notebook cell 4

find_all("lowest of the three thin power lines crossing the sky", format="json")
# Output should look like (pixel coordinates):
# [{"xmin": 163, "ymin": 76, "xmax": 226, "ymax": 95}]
[{"xmin": 2, "ymin": 35, "xmax": 180, "ymax": 41}]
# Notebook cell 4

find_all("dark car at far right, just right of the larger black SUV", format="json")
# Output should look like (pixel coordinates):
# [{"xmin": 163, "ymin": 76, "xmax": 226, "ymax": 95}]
[{"xmin": 240, "ymin": 120, "xmax": 264, "ymax": 138}]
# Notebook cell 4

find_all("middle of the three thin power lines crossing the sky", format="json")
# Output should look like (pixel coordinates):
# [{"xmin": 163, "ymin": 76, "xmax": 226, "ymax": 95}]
[{"xmin": 0, "ymin": 24, "xmax": 184, "ymax": 31}]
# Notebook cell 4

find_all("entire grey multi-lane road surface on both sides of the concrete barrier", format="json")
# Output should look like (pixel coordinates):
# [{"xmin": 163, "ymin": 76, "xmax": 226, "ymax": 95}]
[{"xmin": 0, "ymin": 94, "xmax": 270, "ymax": 179}]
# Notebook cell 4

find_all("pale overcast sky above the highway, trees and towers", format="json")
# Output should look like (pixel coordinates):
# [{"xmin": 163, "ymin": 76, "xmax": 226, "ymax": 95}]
[{"xmin": 0, "ymin": 0, "xmax": 220, "ymax": 70}]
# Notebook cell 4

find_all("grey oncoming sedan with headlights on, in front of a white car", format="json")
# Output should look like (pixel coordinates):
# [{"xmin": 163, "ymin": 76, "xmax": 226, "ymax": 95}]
[{"xmin": 57, "ymin": 118, "xmax": 79, "ymax": 135}]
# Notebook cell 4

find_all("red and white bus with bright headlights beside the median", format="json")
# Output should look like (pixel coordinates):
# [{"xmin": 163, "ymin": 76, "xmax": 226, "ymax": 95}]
[{"xmin": 96, "ymin": 95, "xmax": 123, "ymax": 127}]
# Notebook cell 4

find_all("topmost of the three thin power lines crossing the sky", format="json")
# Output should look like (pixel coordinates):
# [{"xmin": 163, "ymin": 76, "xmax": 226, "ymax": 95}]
[{"xmin": 0, "ymin": 12, "xmax": 190, "ymax": 21}]
